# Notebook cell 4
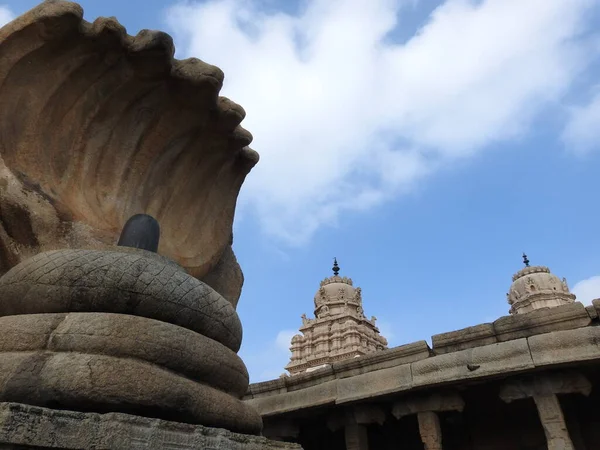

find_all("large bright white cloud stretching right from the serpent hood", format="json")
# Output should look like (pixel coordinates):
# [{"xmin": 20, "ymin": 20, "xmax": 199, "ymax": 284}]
[{"xmin": 168, "ymin": 0, "xmax": 596, "ymax": 243}]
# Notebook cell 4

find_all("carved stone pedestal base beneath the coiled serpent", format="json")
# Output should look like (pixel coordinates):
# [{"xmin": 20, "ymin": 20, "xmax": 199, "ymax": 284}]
[{"xmin": 0, "ymin": 403, "xmax": 301, "ymax": 450}]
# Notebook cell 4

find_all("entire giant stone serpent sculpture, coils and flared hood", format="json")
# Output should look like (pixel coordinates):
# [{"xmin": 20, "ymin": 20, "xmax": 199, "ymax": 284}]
[{"xmin": 0, "ymin": 0, "xmax": 262, "ymax": 434}]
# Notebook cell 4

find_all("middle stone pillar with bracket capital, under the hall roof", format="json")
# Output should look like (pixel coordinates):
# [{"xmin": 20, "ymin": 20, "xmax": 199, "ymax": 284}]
[{"xmin": 392, "ymin": 391, "xmax": 465, "ymax": 450}]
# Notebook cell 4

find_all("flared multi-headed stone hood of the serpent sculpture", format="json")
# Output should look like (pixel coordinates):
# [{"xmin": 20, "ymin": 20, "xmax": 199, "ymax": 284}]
[{"xmin": 0, "ymin": 0, "xmax": 258, "ymax": 305}]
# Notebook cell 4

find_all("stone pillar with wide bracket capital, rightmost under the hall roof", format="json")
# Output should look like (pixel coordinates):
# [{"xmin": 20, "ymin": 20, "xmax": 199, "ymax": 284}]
[{"xmin": 500, "ymin": 372, "xmax": 592, "ymax": 450}]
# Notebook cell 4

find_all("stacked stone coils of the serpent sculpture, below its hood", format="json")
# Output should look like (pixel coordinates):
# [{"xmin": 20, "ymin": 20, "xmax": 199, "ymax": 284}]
[{"xmin": 0, "ymin": 216, "xmax": 262, "ymax": 434}]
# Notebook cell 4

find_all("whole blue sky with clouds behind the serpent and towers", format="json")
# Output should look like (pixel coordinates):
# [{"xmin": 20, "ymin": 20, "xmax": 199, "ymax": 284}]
[{"xmin": 0, "ymin": 0, "xmax": 600, "ymax": 381}]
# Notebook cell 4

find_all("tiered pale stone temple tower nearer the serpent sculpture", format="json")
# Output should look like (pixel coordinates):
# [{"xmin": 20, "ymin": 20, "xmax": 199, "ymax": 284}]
[{"xmin": 286, "ymin": 260, "xmax": 387, "ymax": 375}]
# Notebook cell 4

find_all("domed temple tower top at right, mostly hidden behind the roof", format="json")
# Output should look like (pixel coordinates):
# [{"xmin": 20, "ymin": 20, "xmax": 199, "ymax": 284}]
[{"xmin": 506, "ymin": 253, "xmax": 575, "ymax": 314}]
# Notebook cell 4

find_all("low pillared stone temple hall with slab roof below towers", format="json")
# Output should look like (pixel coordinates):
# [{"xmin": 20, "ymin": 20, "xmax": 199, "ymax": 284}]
[{"xmin": 245, "ymin": 301, "xmax": 600, "ymax": 450}]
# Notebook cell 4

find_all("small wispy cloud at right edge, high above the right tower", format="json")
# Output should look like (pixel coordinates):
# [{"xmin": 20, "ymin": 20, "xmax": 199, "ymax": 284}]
[{"xmin": 563, "ymin": 88, "xmax": 600, "ymax": 154}]
